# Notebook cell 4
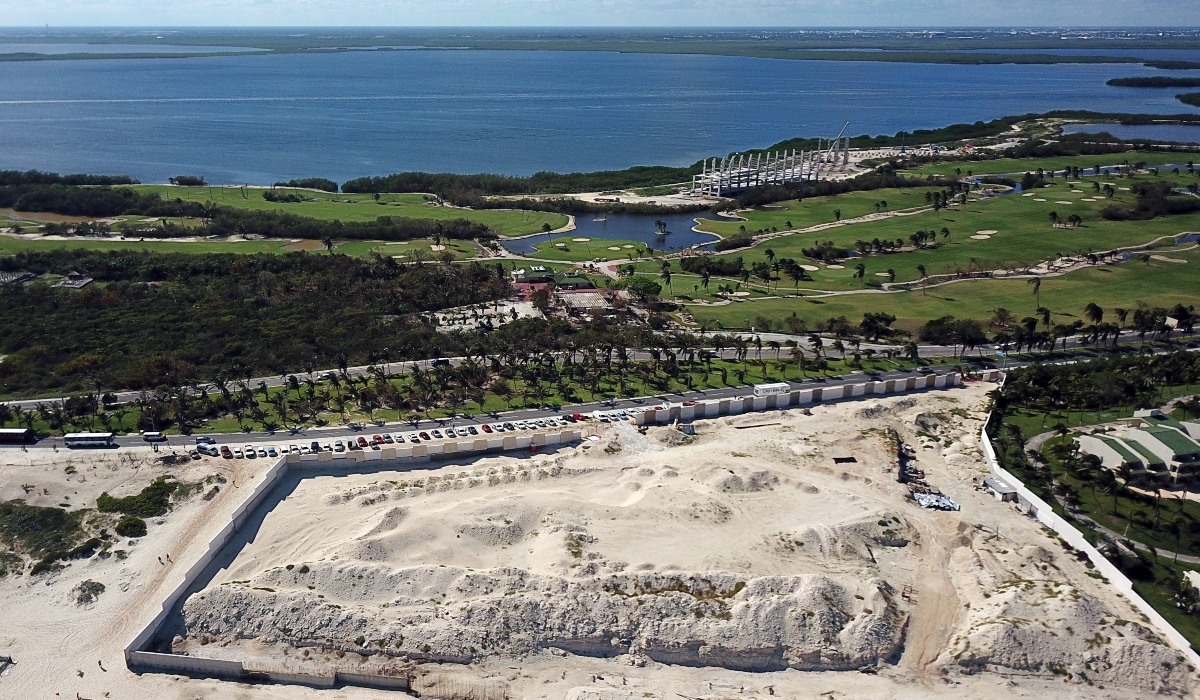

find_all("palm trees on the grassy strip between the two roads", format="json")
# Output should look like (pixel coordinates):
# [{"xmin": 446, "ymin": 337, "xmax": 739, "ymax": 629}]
[{"xmin": 0, "ymin": 325, "xmax": 916, "ymax": 432}]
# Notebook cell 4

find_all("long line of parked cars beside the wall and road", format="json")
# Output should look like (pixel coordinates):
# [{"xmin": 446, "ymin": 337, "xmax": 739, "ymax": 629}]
[{"xmin": 196, "ymin": 414, "xmax": 583, "ymax": 460}]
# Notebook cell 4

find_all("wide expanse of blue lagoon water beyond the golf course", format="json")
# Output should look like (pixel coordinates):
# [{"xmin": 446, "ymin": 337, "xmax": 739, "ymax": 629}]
[{"xmin": 0, "ymin": 50, "xmax": 1193, "ymax": 184}]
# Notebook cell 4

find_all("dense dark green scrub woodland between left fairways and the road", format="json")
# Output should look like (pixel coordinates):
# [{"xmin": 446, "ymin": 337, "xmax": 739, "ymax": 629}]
[{"xmin": 0, "ymin": 250, "xmax": 509, "ymax": 396}]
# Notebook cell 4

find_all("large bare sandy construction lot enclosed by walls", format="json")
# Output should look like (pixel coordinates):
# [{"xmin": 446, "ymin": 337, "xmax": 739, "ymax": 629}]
[{"xmin": 157, "ymin": 385, "xmax": 1195, "ymax": 700}]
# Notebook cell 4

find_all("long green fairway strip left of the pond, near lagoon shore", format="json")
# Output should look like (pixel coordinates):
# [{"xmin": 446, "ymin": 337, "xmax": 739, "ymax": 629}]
[{"xmin": 132, "ymin": 185, "xmax": 569, "ymax": 235}]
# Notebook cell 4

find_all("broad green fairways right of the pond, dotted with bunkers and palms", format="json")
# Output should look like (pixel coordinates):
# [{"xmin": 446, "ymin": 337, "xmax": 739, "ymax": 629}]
[{"xmin": 662, "ymin": 175, "xmax": 1200, "ymax": 292}]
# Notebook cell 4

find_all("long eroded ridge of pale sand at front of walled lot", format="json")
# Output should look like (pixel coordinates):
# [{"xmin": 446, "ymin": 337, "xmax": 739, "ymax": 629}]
[{"xmin": 180, "ymin": 562, "xmax": 906, "ymax": 671}]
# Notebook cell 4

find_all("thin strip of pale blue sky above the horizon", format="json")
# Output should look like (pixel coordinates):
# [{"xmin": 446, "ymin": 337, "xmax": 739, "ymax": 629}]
[{"xmin": 7, "ymin": 0, "xmax": 1200, "ymax": 28}]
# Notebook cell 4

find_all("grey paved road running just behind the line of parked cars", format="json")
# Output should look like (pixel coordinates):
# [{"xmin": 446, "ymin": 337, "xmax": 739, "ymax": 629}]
[{"xmin": 10, "ymin": 367, "xmax": 953, "ymax": 451}]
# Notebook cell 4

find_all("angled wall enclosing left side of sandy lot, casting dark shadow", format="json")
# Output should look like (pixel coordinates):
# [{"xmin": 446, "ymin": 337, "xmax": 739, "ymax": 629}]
[{"xmin": 125, "ymin": 430, "xmax": 583, "ymax": 689}]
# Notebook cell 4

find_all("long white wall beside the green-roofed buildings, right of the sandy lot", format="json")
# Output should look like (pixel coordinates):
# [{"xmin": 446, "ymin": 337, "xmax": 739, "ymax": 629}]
[{"xmin": 979, "ymin": 408, "xmax": 1200, "ymax": 669}]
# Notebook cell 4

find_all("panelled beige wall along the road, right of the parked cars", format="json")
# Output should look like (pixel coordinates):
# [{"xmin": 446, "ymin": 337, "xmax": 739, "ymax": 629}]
[{"xmin": 636, "ymin": 371, "xmax": 979, "ymax": 425}]
